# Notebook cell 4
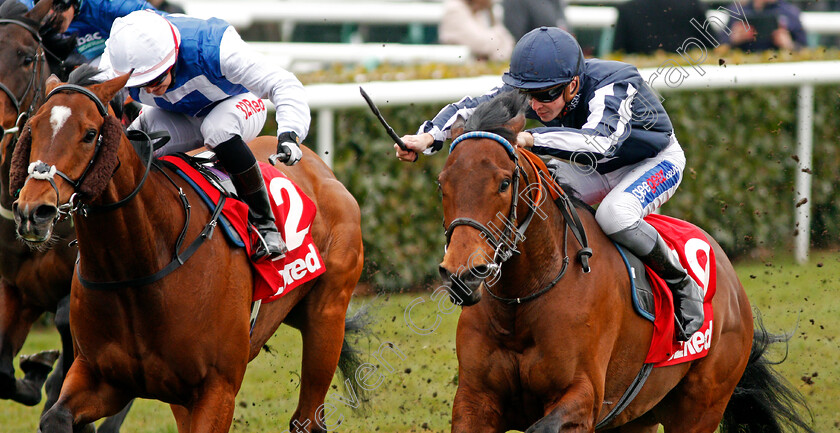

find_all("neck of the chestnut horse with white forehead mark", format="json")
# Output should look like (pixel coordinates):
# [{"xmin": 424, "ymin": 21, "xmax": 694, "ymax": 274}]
[{"xmin": 74, "ymin": 137, "xmax": 184, "ymax": 280}]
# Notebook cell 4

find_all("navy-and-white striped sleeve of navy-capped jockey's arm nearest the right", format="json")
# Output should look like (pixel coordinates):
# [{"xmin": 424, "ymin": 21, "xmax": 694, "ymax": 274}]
[{"xmin": 529, "ymin": 82, "xmax": 638, "ymax": 157}]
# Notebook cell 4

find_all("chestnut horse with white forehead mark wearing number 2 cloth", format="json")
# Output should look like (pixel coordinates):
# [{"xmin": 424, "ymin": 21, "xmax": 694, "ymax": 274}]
[{"xmin": 12, "ymin": 71, "xmax": 363, "ymax": 433}]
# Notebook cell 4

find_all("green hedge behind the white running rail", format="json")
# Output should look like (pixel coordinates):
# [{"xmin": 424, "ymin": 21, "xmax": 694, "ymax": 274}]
[{"xmin": 300, "ymin": 86, "xmax": 840, "ymax": 290}]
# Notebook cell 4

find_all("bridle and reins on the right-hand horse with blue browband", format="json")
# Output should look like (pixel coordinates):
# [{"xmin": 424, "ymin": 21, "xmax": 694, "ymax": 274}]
[{"xmin": 446, "ymin": 131, "xmax": 592, "ymax": 305}]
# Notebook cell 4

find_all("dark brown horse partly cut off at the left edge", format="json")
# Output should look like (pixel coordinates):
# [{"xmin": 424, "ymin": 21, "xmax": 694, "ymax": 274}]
[{"xmin": 0, "ymin": 1, "xmax": 82, "ymax": 412}]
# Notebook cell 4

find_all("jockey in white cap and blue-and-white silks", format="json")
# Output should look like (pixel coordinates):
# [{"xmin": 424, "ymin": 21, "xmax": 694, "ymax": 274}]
[{"xmin": 99, "ymin": 10, "xmax": 310, "ymax": 260}]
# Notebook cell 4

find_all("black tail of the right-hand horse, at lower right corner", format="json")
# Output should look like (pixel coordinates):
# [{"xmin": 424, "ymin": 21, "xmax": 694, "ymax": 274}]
[{"xmin": 720, "ymin": 311, "xmax": 814, "ymax": 433}]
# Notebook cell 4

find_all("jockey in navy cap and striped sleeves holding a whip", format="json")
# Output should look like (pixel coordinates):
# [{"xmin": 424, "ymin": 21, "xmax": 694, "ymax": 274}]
[{"xmin": 395, "ymin": 27, "xmax": 703, "ymax": 341}]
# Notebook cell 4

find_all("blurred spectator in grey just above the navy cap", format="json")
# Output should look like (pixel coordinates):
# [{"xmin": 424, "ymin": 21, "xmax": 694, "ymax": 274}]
[{"xmin": 502, "ymin": 0, "xmax": 569, "ymax": 41}]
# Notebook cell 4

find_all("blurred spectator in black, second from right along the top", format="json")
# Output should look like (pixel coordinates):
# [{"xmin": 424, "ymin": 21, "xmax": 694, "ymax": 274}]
[{"xmin": 613, "ymin": 0, "xmax": 706, "ymax": 54}]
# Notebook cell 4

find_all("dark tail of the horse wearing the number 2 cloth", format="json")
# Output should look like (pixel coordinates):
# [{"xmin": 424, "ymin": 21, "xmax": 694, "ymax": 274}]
[{"xmin": 338, "ymin": 308, "xmax": 371, "ymax": 412}]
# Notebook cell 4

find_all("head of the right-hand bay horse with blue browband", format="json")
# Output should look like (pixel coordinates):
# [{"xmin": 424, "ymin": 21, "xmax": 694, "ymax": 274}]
[{"xmin": 438, "ymin": 92, "xmax": 525, "ymax": 306}]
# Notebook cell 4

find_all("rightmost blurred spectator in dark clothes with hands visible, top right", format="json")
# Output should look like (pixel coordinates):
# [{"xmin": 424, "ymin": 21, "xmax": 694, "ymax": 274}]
[{"xmin": 727, "ymin": 0, "xmax": 808, "ymax": 51}]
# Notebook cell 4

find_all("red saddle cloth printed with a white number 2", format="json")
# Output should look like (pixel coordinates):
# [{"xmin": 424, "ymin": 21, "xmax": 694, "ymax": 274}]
[{"xmin": 161, "ymin": 156, "xmax": 326, "ymax": 302}]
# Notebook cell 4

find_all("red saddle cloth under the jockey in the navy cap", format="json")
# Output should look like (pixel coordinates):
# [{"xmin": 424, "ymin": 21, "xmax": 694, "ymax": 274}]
[{"xmin": 645, "ymin": 214, "xmax": 717, "ymax": 367}]
